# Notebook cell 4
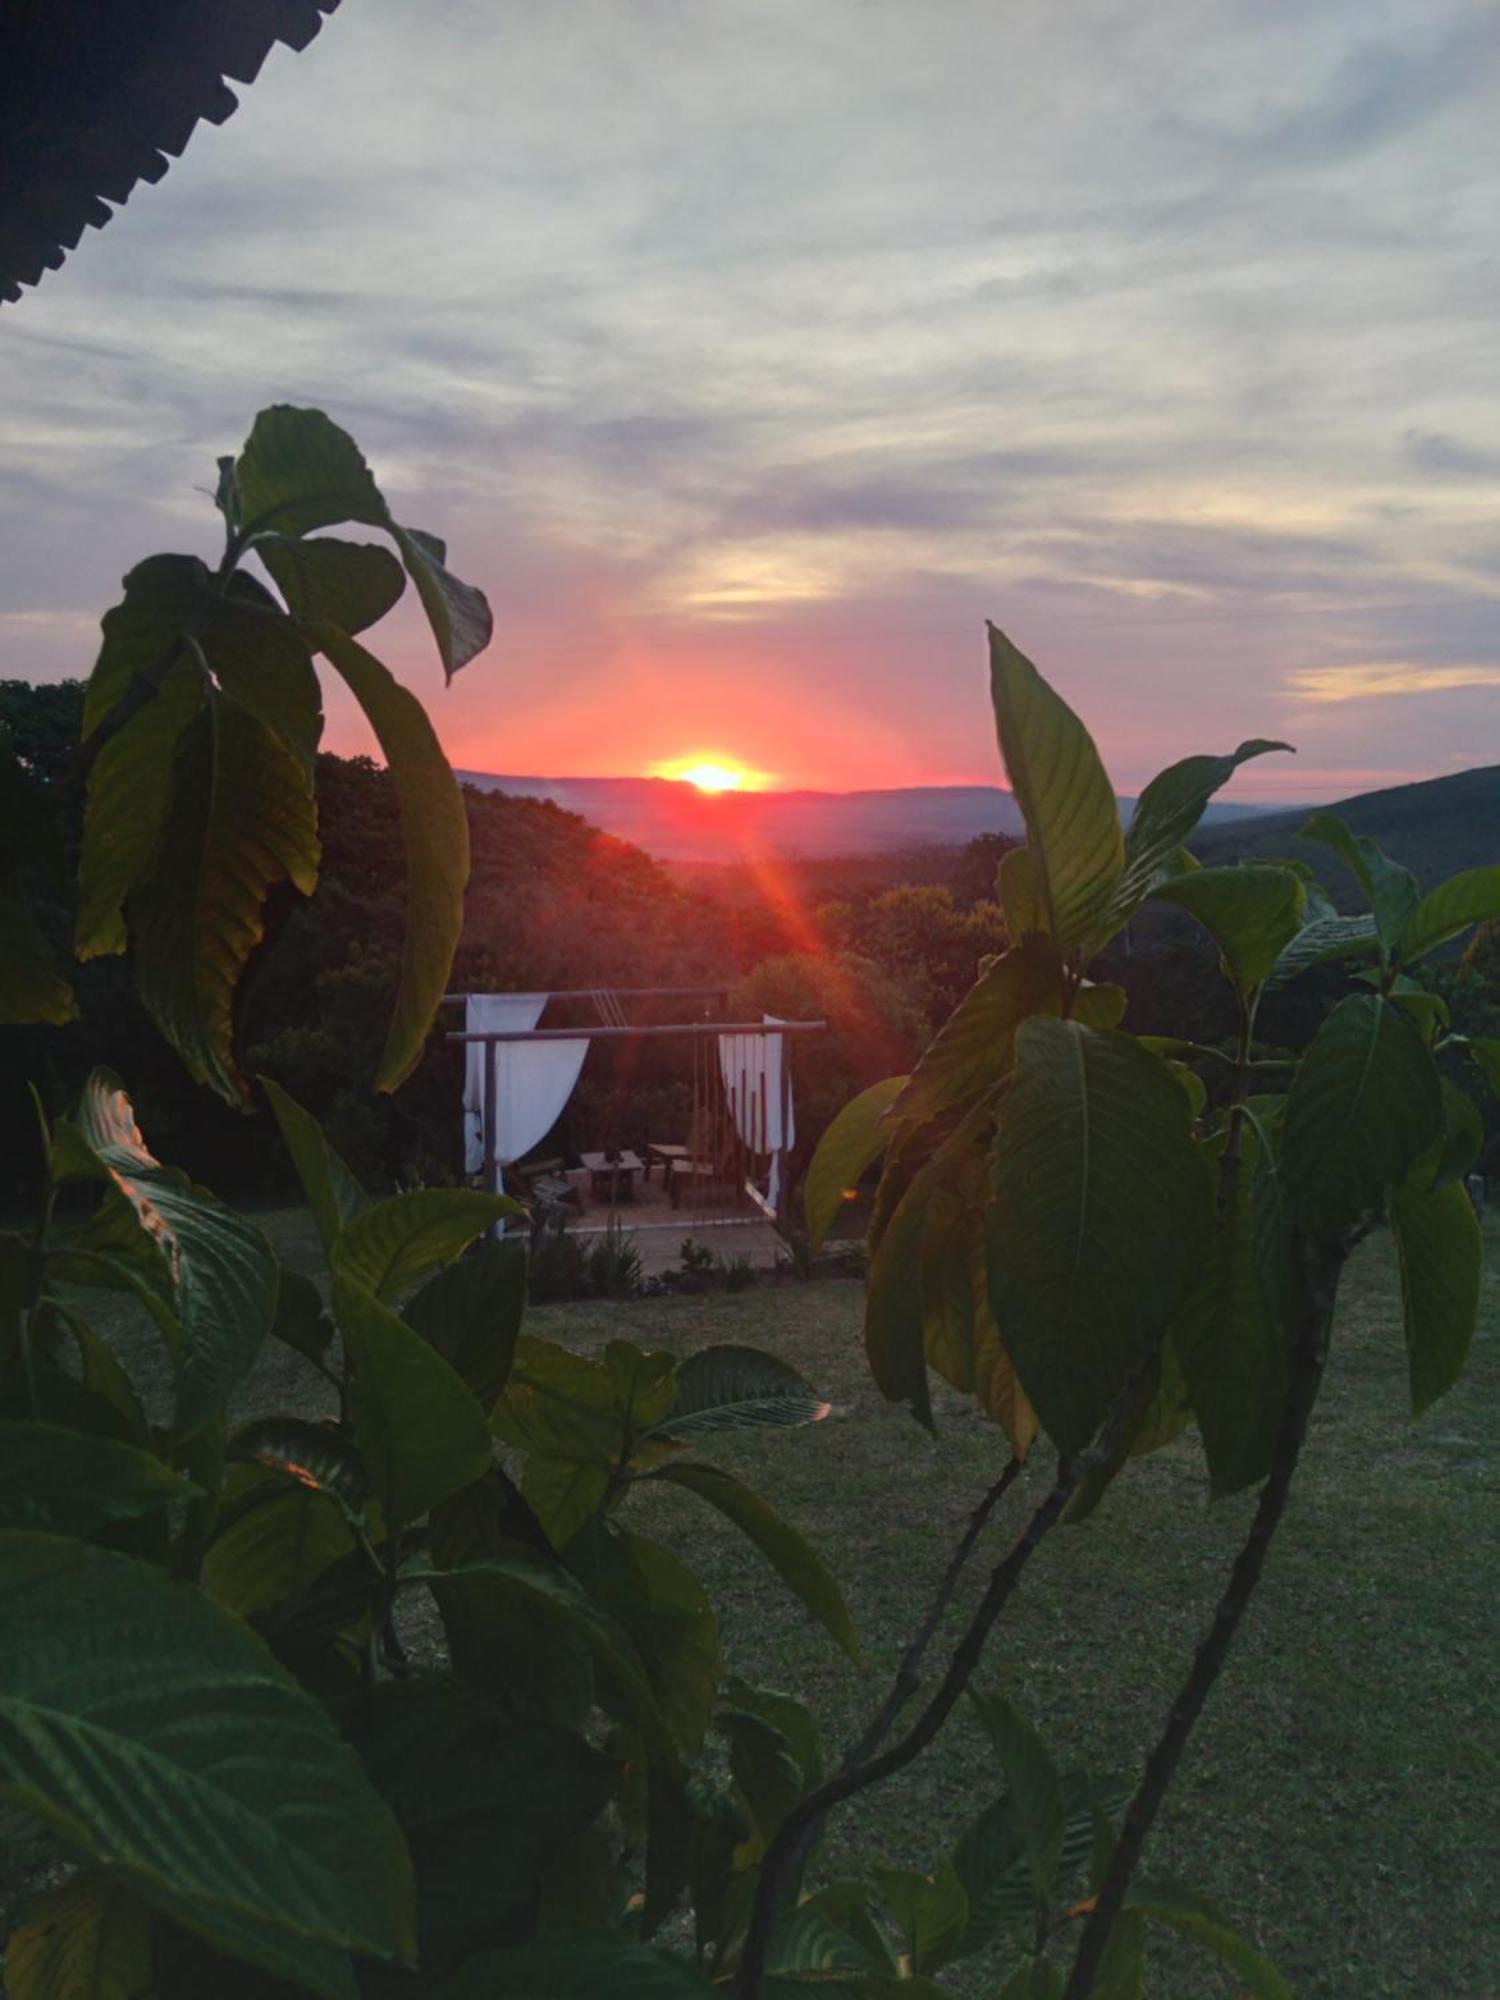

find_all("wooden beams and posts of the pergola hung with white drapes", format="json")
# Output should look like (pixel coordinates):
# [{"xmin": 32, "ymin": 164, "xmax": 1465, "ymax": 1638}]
[{"xmin": 444, "ymin": 986, "xmax": 828, "ymax": 1224}]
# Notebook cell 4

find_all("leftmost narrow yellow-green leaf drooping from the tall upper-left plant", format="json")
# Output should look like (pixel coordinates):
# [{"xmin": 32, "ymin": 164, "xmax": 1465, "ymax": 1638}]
[{"xmin": 74, "ymin": 658, "xmax": 206, "ymax": 958}]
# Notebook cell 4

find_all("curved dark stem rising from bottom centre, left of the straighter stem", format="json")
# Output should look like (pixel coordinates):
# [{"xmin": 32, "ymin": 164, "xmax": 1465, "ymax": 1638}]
[{"xmin": 734, "ymin": 1376, "xmax": 1156, "ymax": 2000}]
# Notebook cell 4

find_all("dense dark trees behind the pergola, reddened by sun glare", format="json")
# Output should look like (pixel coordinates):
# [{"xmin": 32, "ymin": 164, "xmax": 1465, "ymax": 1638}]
[{"xmin": 0, "ymin": 682, "xmax": 1500, "ymax": 1200}]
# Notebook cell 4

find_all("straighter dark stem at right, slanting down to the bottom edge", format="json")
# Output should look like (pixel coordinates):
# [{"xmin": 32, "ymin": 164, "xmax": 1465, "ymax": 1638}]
[{"xmin": 1064, "ymin": 1244, "xmax": 1348, "ymax": 2000}]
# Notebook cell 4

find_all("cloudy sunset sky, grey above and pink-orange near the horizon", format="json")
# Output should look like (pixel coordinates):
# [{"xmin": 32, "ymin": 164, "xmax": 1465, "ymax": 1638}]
[{"xmin": 0, "ymin": 0, "xmax": 1500, "ymax": 802}]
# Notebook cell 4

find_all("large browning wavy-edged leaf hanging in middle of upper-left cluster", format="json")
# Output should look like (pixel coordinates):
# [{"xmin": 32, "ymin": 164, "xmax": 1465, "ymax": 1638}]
[{"xmin": 130, "ymin": 690, "xmax": 318, "ymax": 1104}]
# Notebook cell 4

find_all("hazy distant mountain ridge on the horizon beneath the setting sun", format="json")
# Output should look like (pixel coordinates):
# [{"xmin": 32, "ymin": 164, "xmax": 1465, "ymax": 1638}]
[{"xmin": 458, "ymin": 770, "xmax": 1264, "ymax": 862}]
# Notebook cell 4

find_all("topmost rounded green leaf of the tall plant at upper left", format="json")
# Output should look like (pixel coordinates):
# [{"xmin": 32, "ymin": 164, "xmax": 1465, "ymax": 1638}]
[{"xmin": 234, "ymin": 402, "xmax": 390, "ymax": 536}]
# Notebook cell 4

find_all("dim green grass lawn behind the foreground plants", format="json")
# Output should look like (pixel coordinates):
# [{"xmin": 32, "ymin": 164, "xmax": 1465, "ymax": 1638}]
[{"xmin": 35, "ymin": 1212, "xmax": 1500, "ymax": 2000}]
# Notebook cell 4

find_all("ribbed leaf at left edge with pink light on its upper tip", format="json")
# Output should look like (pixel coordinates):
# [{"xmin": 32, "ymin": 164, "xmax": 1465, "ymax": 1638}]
[{"xmin": 76, "ymin": 1070, "xmax": 276, "ymax": 1430}]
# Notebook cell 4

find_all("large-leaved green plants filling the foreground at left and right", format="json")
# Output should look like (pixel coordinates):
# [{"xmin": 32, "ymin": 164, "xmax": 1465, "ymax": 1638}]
[{"xmin": 0, "ymin": 412, "xmax": 1500, "ymax": 2000}]
